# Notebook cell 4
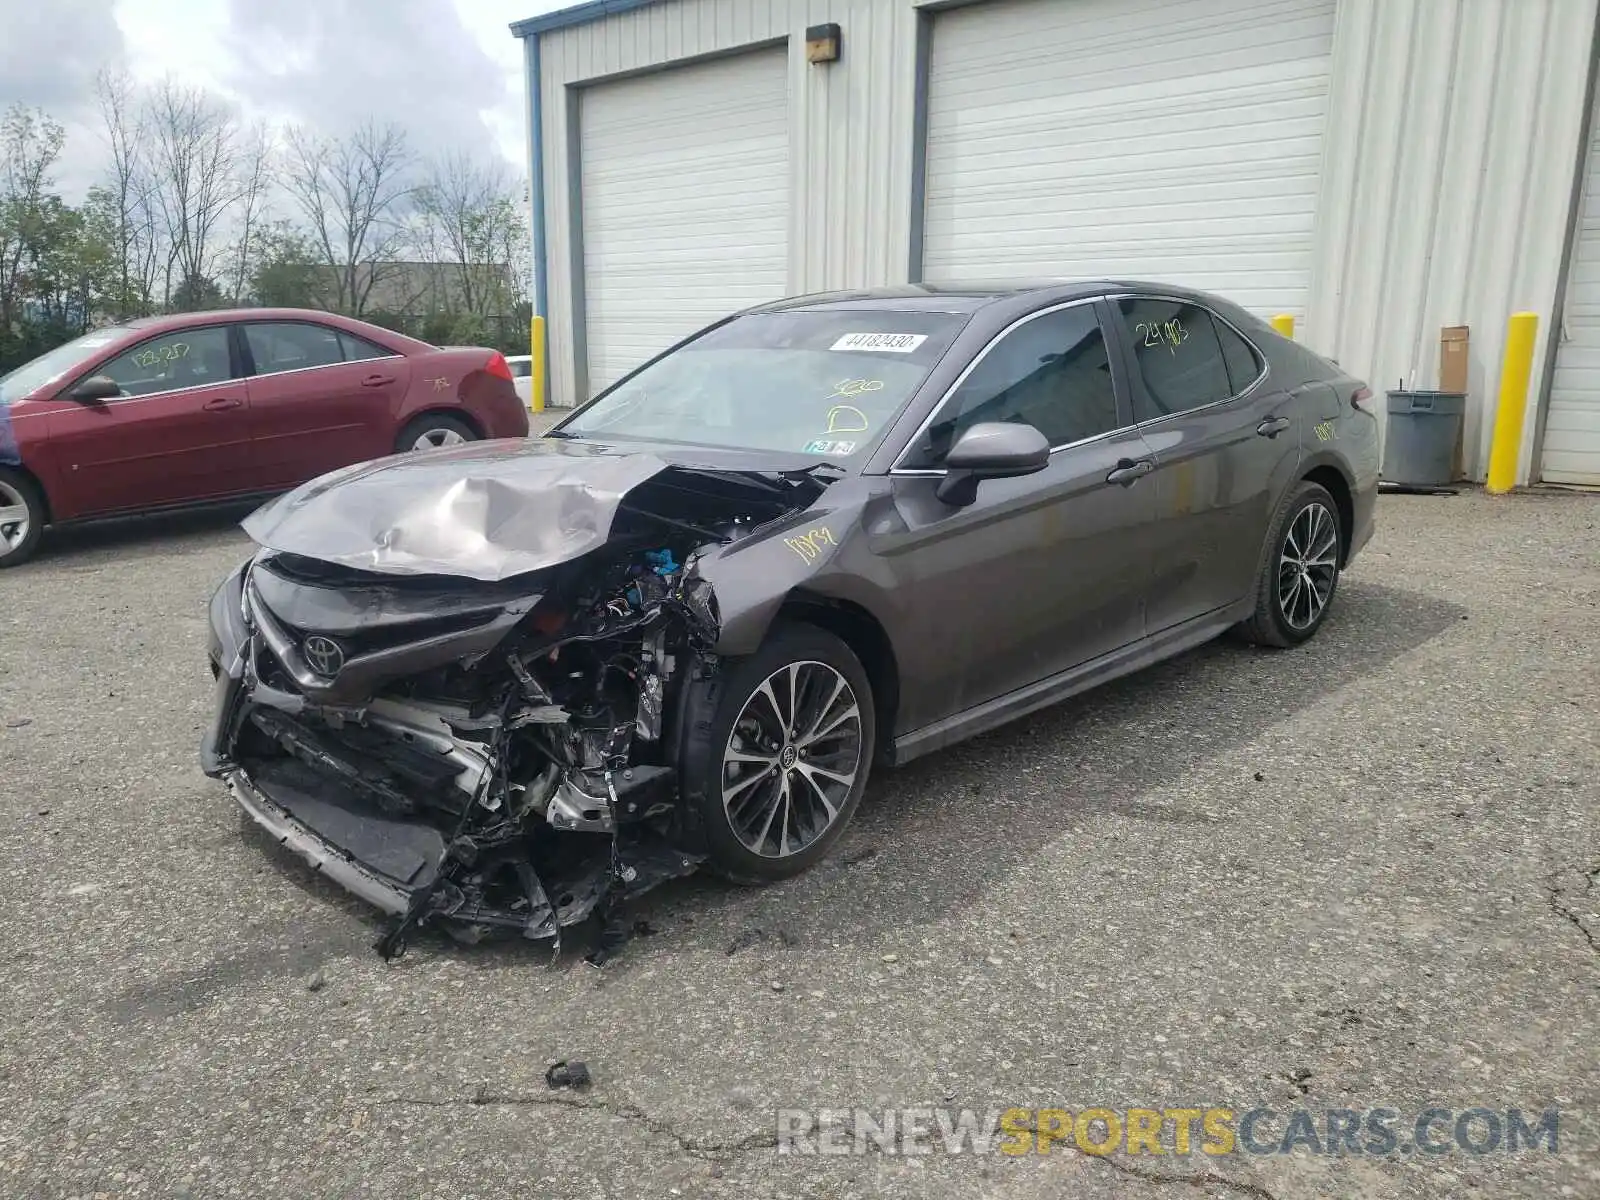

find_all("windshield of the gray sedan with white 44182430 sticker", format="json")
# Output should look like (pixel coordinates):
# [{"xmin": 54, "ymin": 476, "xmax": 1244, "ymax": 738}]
[{"xmin": 560, "ymin": 309, "xmax": 966, "ymax": 461}]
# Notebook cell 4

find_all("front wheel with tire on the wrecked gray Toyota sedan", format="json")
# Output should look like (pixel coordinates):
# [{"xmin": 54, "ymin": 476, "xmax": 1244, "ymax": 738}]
[{"xmin": 680, "ymin": 624, "xmax": 877, "ymax": 883}]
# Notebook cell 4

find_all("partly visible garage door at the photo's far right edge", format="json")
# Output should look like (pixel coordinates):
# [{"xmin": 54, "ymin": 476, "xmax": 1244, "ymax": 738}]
[{"xmin": 1541, "ymin": 96, "xmax": 1600, "ymax": 485}]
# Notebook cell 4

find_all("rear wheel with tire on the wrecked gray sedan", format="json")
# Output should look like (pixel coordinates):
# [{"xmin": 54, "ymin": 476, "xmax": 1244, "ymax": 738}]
[{"xmin": 1238, "ymin": 480, "xmax": 1344, "ymax": 650}]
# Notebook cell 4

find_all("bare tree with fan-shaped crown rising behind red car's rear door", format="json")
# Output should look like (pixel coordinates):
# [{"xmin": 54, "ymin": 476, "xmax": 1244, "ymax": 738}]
[{"xmin": 283, "ymin": 122, "xmax": 411, "ymax": 317}]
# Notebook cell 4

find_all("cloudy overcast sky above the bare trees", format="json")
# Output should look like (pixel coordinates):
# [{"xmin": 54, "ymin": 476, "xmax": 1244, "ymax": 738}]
[{"xmin": 0, "ymin": 0, "xmax": 573, "ymax": 192}]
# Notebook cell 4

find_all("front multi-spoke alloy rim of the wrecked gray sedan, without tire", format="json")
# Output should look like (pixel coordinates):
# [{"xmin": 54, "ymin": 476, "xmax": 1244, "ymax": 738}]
[{"xmin": 722, "ymin": 661, "xmax": 862, "ymax": 858}]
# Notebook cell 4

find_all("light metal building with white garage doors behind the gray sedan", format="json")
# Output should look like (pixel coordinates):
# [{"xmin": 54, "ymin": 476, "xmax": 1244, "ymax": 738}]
[{"xmin": 512, "ymin": 0, "xmax": 1600, "ymax": 485}]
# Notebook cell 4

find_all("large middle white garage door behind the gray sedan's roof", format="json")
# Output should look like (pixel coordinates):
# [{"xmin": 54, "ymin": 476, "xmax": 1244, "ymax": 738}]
[{"xmin": 923, "ymin": 0, "xmax": 1334, "ymax": 315}]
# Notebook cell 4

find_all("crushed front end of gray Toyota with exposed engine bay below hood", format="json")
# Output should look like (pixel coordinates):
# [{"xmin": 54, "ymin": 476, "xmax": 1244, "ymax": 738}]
[{"xmin": 203, "ymin": 467, "xmax": 829, "ymax": 957}]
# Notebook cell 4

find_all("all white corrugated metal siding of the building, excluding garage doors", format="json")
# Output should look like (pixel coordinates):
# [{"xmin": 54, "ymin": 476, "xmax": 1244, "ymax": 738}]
[{"xmin": 541, "ymin": 0, "xmax": 1600, "ymax": 480}]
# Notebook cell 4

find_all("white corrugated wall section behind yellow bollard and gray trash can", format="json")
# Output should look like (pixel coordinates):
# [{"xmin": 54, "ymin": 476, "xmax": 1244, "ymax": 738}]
[{"xmin": 1304, "ymin": 0, "xmax": 1595, "ymax": 482}]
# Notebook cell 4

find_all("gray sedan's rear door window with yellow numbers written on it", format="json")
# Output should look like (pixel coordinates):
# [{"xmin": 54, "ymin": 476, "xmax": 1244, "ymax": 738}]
[{"xmin": 1115, "ymin": 296, "xmax": 1234, "ymax": 422}]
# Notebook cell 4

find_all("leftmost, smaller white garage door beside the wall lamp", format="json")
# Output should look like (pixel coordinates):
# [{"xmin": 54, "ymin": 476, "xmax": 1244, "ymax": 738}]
[{"xmin": 579, "ymin": 50, "xmax": 789, "ymax": 395}]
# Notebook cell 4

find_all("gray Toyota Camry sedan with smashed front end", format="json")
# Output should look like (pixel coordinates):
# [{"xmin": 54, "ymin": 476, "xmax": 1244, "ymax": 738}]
[{"xmin": 202, "ymin": 283, "xmax": 1378, "ymax": 957}]
